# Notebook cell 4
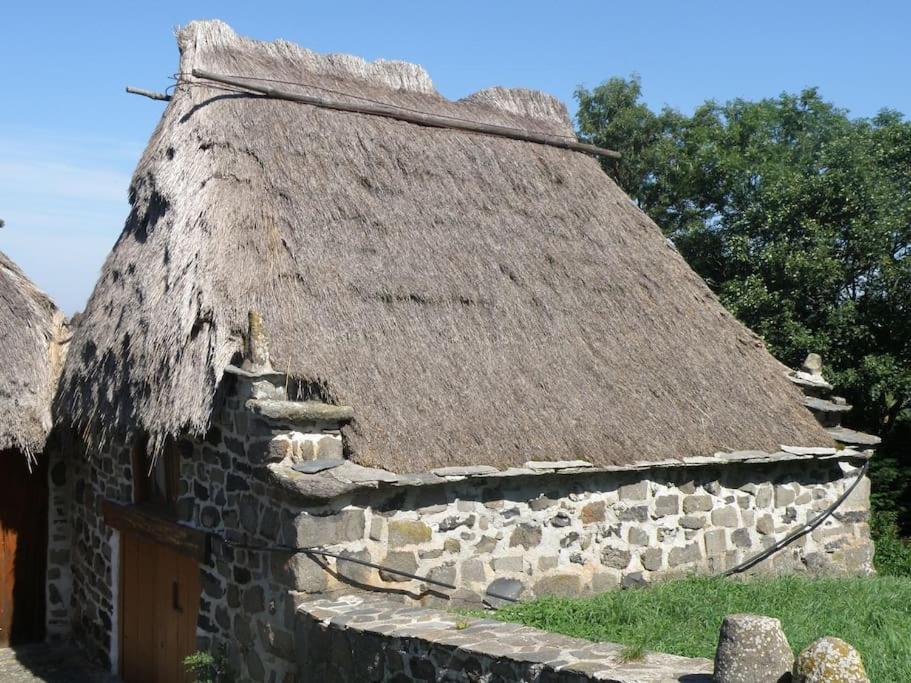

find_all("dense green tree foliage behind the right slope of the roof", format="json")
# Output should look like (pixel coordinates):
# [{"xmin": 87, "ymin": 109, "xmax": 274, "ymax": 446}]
[{"xmin": 576, "ymin": 77, "xmax": 911, "ymax": 521}]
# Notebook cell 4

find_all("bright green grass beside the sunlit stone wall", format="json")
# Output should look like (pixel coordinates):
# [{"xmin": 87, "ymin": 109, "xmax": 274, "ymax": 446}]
[{"xmin": 480, "ymin": 576, "xmax": 911, "ymax": 683}]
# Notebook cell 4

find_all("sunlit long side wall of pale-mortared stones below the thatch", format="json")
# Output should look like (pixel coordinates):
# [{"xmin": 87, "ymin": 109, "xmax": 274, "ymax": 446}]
[{"xmin": 283, "ymin": 460, "xmax": 872, "ymax": 604}]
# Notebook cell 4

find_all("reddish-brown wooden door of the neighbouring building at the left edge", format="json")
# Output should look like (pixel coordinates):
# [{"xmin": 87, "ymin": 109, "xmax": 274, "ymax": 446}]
[{"xmin": 0, "ymin": 451, "xmax": 47, "ymax": 646}]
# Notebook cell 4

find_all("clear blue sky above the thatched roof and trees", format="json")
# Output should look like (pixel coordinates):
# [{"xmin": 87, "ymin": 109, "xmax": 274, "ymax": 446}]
[{"xmin": 0, "ymin": 0, "xmax": 911, "ymax": 313}]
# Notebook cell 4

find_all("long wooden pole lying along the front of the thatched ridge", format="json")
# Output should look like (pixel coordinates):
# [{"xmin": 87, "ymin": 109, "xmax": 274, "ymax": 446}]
[{"xmin": 193, "ymin": 69, "xmax": 620, "ymax": 159}]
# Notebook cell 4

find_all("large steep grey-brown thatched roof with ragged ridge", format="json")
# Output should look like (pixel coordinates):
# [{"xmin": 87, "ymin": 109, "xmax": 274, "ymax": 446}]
[{"xmin": 53, "ymin": 22, "xmax": 830, "ymax": 472}]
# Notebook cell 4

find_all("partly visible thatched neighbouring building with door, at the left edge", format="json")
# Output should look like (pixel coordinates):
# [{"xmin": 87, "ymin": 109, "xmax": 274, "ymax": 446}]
[{"xmin": 0, "ymin": 252, "xmax": 67, "ymax": 646}]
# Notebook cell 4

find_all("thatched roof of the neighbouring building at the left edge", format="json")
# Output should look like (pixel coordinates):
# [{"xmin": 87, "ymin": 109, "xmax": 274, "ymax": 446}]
[{"xmin": 0, "ymin": 252, "xmax": 65, "ymax": 456}]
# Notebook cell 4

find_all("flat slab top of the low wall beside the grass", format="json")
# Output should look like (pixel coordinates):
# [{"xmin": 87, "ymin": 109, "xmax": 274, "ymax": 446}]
[{"xmin": 298, "ymin": 595, "xmax": 713, "ymax": 683}]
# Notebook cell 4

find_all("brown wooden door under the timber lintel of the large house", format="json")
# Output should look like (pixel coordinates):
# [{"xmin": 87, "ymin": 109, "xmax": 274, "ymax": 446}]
[{"xmin": 120, "ymin": 532, "xmax": 201, "ymax": 683}]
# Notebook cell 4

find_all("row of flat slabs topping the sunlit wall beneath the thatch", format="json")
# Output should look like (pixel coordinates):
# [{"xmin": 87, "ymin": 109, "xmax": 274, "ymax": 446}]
[{"xmin": 266, "ymin": 446, "xmax": 875, "ymax": 501}]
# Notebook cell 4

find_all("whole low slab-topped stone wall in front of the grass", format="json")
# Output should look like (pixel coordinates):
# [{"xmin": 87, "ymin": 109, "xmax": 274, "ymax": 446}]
[{"xmin": 295, "ymin": 596, "xmax": 712, "ymax": 683}]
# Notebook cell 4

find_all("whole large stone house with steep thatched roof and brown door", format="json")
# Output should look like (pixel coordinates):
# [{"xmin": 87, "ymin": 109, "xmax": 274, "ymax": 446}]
[{"xmin": 50, "ymin": 22, "xmax": 872, "ymax": 683}]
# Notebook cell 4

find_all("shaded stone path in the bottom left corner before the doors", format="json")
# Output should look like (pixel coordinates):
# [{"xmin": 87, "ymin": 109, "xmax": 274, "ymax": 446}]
[{"xmin": 0, "ymin": 643, "xmax": 120, "ymax": 683}]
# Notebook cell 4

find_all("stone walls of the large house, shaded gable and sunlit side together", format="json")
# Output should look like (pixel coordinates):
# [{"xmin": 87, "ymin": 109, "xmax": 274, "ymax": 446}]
[{"xmin": 64, "ymin": 368, "xmax": 872, "ymax": 681}]
